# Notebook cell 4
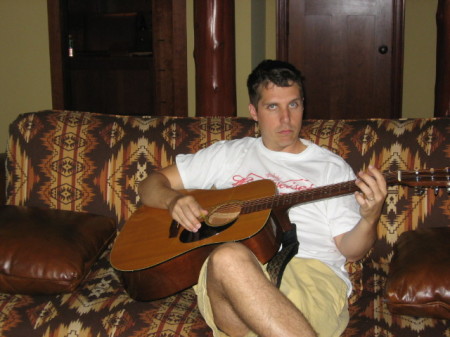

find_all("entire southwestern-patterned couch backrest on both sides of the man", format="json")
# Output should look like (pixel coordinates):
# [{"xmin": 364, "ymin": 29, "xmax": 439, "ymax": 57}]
[{"xmin": 7, "ymin": 110, "xmax": 450, "ymax": 262}]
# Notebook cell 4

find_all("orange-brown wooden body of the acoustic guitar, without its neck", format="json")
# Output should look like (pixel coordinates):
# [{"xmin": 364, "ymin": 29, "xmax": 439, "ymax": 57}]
[{"xmin": 110, "ymin": 180, "xmax": 280, "ymax": 300}]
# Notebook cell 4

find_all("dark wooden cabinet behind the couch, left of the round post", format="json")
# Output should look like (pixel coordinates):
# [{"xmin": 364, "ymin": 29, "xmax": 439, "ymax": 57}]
[{"xmin": 48, "ymin": 0, "xmax": 187, "ymax": 116}]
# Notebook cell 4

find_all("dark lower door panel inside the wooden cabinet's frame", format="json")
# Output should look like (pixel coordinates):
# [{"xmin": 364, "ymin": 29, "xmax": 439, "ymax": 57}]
[{"xmin": 65, "ymin": 57, "xmax": 157, "ymax": 116}]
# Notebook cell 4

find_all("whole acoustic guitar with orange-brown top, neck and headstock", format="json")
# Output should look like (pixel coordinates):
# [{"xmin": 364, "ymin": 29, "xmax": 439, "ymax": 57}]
[{"xmin": 110, "ymin": 168, "xmax": 450, "ymax": 300}]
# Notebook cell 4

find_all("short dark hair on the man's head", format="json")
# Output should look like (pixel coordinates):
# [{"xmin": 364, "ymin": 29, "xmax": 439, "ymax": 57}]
[{"xmin": 247, "ymin": 60, "xmax": 303, "ymax": 107}]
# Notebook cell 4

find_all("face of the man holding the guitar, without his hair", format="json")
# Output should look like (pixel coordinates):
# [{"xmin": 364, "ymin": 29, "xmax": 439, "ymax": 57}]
[{"xmin": 249, "ymin": 83, "xmax": 305, "ymax": 153}]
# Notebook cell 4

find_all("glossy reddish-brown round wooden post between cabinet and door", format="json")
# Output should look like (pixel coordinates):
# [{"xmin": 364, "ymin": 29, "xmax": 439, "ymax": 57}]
[{"xmin": 194, "ymin": 0, "xmax": 236, "ymax": 116}]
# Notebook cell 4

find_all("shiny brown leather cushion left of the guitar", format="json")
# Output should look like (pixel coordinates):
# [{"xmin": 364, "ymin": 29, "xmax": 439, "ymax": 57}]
[{"xmin": 0, "ymin": 206, "xmax": 116, "ymax": 294}]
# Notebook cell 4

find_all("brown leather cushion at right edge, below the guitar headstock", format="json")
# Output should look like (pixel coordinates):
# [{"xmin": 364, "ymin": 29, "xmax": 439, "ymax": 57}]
[{"xmin": 385, "ymin": 227, "xmax": 450, "ymax": 319}]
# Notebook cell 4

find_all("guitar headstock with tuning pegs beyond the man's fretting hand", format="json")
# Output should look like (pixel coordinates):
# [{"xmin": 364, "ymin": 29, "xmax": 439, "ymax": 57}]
[{"xmin": 385, "ymin": 167, "xmax": 450, "ymax": 193}]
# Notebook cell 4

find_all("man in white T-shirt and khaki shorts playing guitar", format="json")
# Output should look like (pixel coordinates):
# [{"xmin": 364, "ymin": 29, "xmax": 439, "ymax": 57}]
[{"xmin": 139, "ymin": 60, "xmax": 387, "ymax": 337}]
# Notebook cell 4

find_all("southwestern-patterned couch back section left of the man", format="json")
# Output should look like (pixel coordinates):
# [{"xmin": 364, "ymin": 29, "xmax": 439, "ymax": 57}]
[{"xmin": 7, "ymin": 111, "xmax": 257, "ymax": 227}]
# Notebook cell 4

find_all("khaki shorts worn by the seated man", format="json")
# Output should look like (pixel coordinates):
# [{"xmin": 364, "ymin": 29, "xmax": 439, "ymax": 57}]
[{"xmin": 194, "ymin": 257, "xmax": 349, "ymax": 337}]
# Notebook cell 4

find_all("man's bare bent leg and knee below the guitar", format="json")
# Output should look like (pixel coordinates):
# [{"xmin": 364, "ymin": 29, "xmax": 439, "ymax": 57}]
[{"xmin": 207, "ymin": 243, "xmax": 317, "ymax": 337}]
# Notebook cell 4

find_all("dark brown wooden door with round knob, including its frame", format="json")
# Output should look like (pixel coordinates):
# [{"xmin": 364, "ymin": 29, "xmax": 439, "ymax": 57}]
[{"xmin": 277, "ymin": 0, "xmax": 403, "ymax": 119}]
